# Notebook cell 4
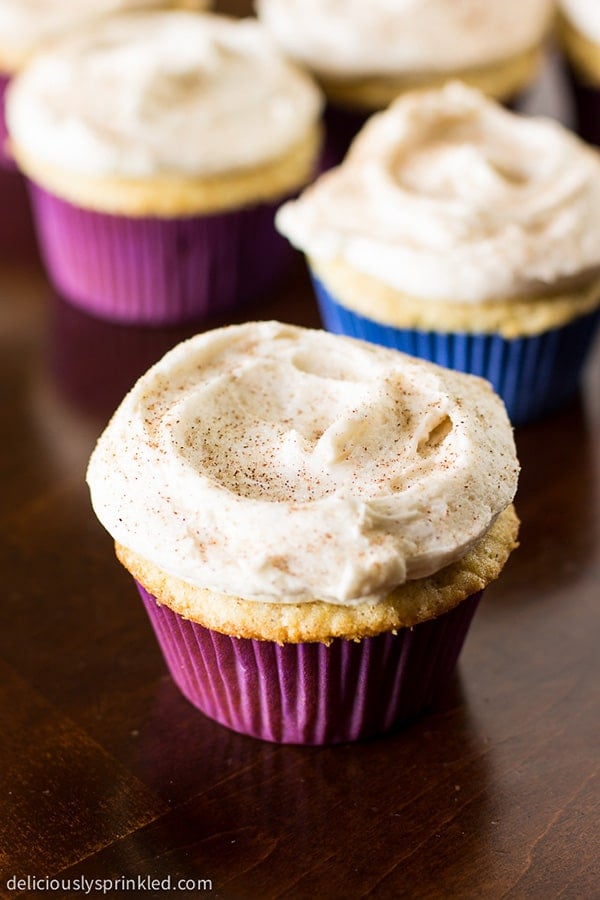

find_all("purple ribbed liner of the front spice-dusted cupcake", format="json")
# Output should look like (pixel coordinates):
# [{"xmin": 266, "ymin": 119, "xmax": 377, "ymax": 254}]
[{"xmin": 136, "ymin": 582, "xmax": 483, "ymax": 745}]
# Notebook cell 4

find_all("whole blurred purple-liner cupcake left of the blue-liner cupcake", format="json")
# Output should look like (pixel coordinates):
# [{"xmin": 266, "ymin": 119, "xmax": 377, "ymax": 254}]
[{"xmin": 7, "ymin": 11, "xmax": 321, "ymax": 325}]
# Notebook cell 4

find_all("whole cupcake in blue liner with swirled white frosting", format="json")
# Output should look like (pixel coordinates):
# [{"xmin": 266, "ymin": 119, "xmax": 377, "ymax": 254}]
[{"xmin": 277, "ymin": 83, "xmax": 600, "ymax": 424}]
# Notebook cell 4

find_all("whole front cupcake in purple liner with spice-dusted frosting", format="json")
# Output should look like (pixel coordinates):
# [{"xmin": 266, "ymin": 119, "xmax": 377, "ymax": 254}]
[{"xmin": 87, "ymin": 322, "xmax": 518, "ymax": 744}]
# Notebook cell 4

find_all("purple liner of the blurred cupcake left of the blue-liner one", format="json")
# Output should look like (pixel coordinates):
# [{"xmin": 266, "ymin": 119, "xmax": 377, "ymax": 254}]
[{"xmin": 29, "ymin": 182, "xmax": 293, "ymax": 325}]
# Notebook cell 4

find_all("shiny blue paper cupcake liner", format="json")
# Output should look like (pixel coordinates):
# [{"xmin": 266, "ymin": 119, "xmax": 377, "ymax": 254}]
[{"xmin": 313, "ymin": 278, "xmax": 600, "ymax": 425}]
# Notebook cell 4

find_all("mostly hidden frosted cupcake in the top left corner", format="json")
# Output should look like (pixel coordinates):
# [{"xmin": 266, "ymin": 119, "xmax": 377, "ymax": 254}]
[{"xmin": 0, "ymin": 0, "xmax": 209, "ymax": 167}]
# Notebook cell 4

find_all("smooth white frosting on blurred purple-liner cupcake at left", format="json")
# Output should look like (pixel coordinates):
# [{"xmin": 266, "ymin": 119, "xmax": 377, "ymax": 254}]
[{"xmin": 7, "ymin": 11, "xmax": 321, "ymax": 177}]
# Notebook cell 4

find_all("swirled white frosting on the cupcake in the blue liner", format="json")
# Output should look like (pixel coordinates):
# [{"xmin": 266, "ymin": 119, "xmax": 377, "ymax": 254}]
[{"xmin": 277, "ymin": 83, "xmax": 600, "ymax": 303}]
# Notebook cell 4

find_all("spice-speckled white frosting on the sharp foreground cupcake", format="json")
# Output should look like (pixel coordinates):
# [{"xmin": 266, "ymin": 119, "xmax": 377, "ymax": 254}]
[{"xmin": 87, "ymin": 322, "xmax": 518, "ymax": 604}]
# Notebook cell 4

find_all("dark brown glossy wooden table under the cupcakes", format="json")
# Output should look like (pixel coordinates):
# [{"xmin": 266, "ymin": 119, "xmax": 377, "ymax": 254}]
[{"xmin": 0, "ymin": 3, "xmax": 600, "ymax": 900}]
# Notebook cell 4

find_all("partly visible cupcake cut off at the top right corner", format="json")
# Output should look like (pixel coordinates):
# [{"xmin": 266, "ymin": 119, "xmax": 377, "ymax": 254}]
[{"xmin": 558, "ymin": 0, "xmax": 600, "ymax": 144}]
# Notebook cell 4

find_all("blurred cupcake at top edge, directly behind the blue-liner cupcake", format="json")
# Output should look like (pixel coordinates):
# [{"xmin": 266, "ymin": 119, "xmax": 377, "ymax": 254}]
[{"xmin": 256, "ymin": 0, "xmax": 554, "ymax": 167}]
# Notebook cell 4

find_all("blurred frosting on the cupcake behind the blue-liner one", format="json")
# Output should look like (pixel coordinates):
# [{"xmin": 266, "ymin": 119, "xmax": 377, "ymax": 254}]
[{"xmin": 256, "ymin": 0, "xmax": 553, "ymax": 78}]
